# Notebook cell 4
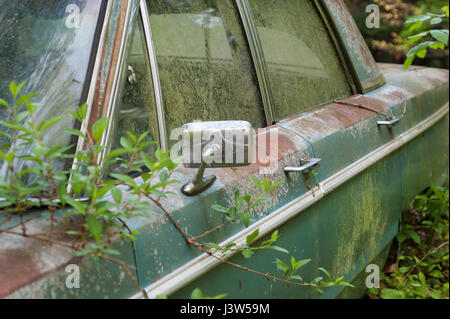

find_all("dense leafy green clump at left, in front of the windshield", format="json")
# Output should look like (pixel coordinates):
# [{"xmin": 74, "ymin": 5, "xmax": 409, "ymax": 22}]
[{"xmin": 0, "ymin": 82, "xmax": 178, "ymax": 259}]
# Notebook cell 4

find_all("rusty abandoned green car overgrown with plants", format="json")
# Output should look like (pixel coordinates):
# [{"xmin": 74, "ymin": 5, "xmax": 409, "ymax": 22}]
[{"xmin": 0, "ymin": 0, "xmax": 449, "ymax": 298}]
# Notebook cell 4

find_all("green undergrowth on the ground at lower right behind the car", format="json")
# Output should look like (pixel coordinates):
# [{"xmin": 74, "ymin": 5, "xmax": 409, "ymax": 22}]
[{"xmin": 369, "ymin": 180, "xmax": 449, "ymax": 299}]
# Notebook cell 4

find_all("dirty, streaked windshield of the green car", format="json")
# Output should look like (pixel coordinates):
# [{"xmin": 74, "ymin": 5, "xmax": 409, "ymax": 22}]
[{"xmin": 0, "ymin": 0, "xmax": 102, "ymax": 180}]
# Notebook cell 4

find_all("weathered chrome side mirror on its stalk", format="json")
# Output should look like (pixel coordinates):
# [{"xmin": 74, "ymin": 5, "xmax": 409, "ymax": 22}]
[{"xmin": 181, "ymin": 121, "xmax": 254, "ymax": 196}]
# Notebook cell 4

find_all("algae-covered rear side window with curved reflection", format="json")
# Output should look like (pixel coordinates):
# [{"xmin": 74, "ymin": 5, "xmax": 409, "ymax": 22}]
[{"xmin": 249, "ymin": 0, "xmax": 351, "ymax": 120}]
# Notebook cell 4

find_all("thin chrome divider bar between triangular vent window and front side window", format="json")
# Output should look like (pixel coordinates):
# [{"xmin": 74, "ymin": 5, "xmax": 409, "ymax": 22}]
[{"xmin": 140, "ymin": 0, "xmax": 169, "ymax": 153}]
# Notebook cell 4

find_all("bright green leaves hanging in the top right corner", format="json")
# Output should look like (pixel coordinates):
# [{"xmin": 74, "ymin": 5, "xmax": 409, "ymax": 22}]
[{"xmin": 403, "ymin": 6, "xmax": 449, "ymax": 69}]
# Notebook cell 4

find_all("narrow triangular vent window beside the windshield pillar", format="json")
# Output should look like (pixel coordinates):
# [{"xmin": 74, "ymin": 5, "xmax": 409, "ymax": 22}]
[{"xmin": 108, "ymin": 13, "xmax": 159, "ymax": 162}]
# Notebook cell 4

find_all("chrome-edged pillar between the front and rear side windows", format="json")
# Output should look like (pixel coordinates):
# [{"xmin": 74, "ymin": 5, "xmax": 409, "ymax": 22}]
[{"xmin": 236, "ymin": 0, "xmax": 275, "ymax": 126}]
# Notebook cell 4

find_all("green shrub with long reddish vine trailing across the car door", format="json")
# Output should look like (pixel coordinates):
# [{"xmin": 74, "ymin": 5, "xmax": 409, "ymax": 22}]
[{"xmin": 0, "ymin": 82, "xmax": 351, "ymax": 299}]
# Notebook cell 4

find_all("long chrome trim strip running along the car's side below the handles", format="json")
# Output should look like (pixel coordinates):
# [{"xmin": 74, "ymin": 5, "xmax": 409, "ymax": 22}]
[{"xmin": 131, "ymin": 102, "xmax": 449, "ymax": 299}]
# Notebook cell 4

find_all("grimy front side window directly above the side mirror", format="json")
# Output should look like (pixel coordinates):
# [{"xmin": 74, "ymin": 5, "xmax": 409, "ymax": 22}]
[{"xmin": 147, "ymin": 0, "xmax": 266, "ymax": 143}]
